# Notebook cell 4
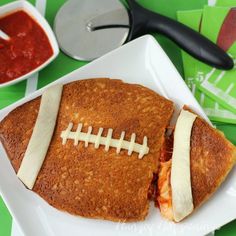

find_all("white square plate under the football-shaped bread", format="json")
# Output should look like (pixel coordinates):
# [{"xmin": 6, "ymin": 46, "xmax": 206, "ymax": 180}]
[{"xmin": 0, "ymin": 36, "xmax": 236, "ymax": 236}]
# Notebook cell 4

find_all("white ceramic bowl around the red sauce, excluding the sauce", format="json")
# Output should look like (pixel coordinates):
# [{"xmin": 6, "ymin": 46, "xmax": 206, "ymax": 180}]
[{"xmin": 0, "ymin": 1, "xmax": 59, "ymax": 88}]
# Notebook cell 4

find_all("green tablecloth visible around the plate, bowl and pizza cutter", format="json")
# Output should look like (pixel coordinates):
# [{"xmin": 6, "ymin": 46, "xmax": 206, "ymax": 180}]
[{"xmin": 0, "ymin": 0, "xmax": 236, "ymax": 236}]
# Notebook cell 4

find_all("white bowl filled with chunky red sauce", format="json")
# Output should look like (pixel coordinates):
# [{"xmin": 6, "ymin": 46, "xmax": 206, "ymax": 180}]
[{"xmin": 0, "ymin": 1, "xmax": 59, "ymax": 87}]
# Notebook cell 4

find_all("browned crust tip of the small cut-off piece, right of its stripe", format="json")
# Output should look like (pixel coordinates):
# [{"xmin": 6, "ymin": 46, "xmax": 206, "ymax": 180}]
[{"xmin": 191, "ymin": 118, "xmax": 236, "ymax": 208}]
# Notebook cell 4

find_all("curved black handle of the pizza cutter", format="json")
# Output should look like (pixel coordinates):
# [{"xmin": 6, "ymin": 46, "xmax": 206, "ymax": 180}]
[{"xmin": 128, "ymin": 0, "xmax": 234, "ymax": 70}]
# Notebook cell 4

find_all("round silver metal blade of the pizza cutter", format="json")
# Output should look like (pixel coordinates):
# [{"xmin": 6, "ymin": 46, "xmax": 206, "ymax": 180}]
[{"xmin": 54, "ymin": 0, "xmax": 130, "ymax": 61}]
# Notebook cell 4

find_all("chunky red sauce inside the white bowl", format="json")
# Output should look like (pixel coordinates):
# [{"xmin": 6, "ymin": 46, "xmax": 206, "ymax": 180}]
[{"xmin": 0, "ymin": 10, "xmax": 53, "ymax": 84}]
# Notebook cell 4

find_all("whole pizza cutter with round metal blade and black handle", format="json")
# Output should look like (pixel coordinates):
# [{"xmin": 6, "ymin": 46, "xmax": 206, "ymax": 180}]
[{"xmin": 54, "ymin": 0, "xmax": 234, "ymax": 70}]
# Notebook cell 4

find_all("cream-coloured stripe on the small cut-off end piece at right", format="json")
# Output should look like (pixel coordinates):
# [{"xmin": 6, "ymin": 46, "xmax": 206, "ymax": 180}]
[{"xmin": 171, "ymin": 110, "xmax": 197, "ymax": 222}]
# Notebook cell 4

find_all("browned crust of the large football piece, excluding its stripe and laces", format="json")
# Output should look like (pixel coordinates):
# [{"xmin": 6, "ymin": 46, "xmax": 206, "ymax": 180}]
[{"xmin": 0, "ymin": 79, "xmax": 173, "ymax": 221}]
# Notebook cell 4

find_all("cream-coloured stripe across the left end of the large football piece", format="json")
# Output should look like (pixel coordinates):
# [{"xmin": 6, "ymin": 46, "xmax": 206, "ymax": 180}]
[{"xmin": 17, "ymin": 84, "xmax": 63, "ymax": 189}]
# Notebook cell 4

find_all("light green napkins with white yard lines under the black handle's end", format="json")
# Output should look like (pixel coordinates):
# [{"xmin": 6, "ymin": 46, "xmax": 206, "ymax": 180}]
[{"xmin": 195, "ymin": 6, "xmax": 236, "ymax": 114}]
